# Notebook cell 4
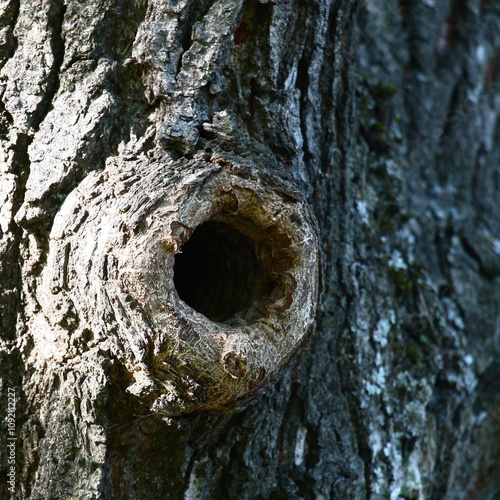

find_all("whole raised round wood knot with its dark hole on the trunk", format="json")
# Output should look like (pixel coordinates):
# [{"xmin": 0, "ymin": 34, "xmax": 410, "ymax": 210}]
[{"xmin": 40, "ymin": 156, "xmax": 319, "ymax": 415}]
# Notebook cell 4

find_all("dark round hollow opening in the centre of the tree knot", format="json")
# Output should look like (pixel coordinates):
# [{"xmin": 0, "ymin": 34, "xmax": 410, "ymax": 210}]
[{"xmin": 174, "ymin": 220, "xmax": 273, "ymax": 323}]
